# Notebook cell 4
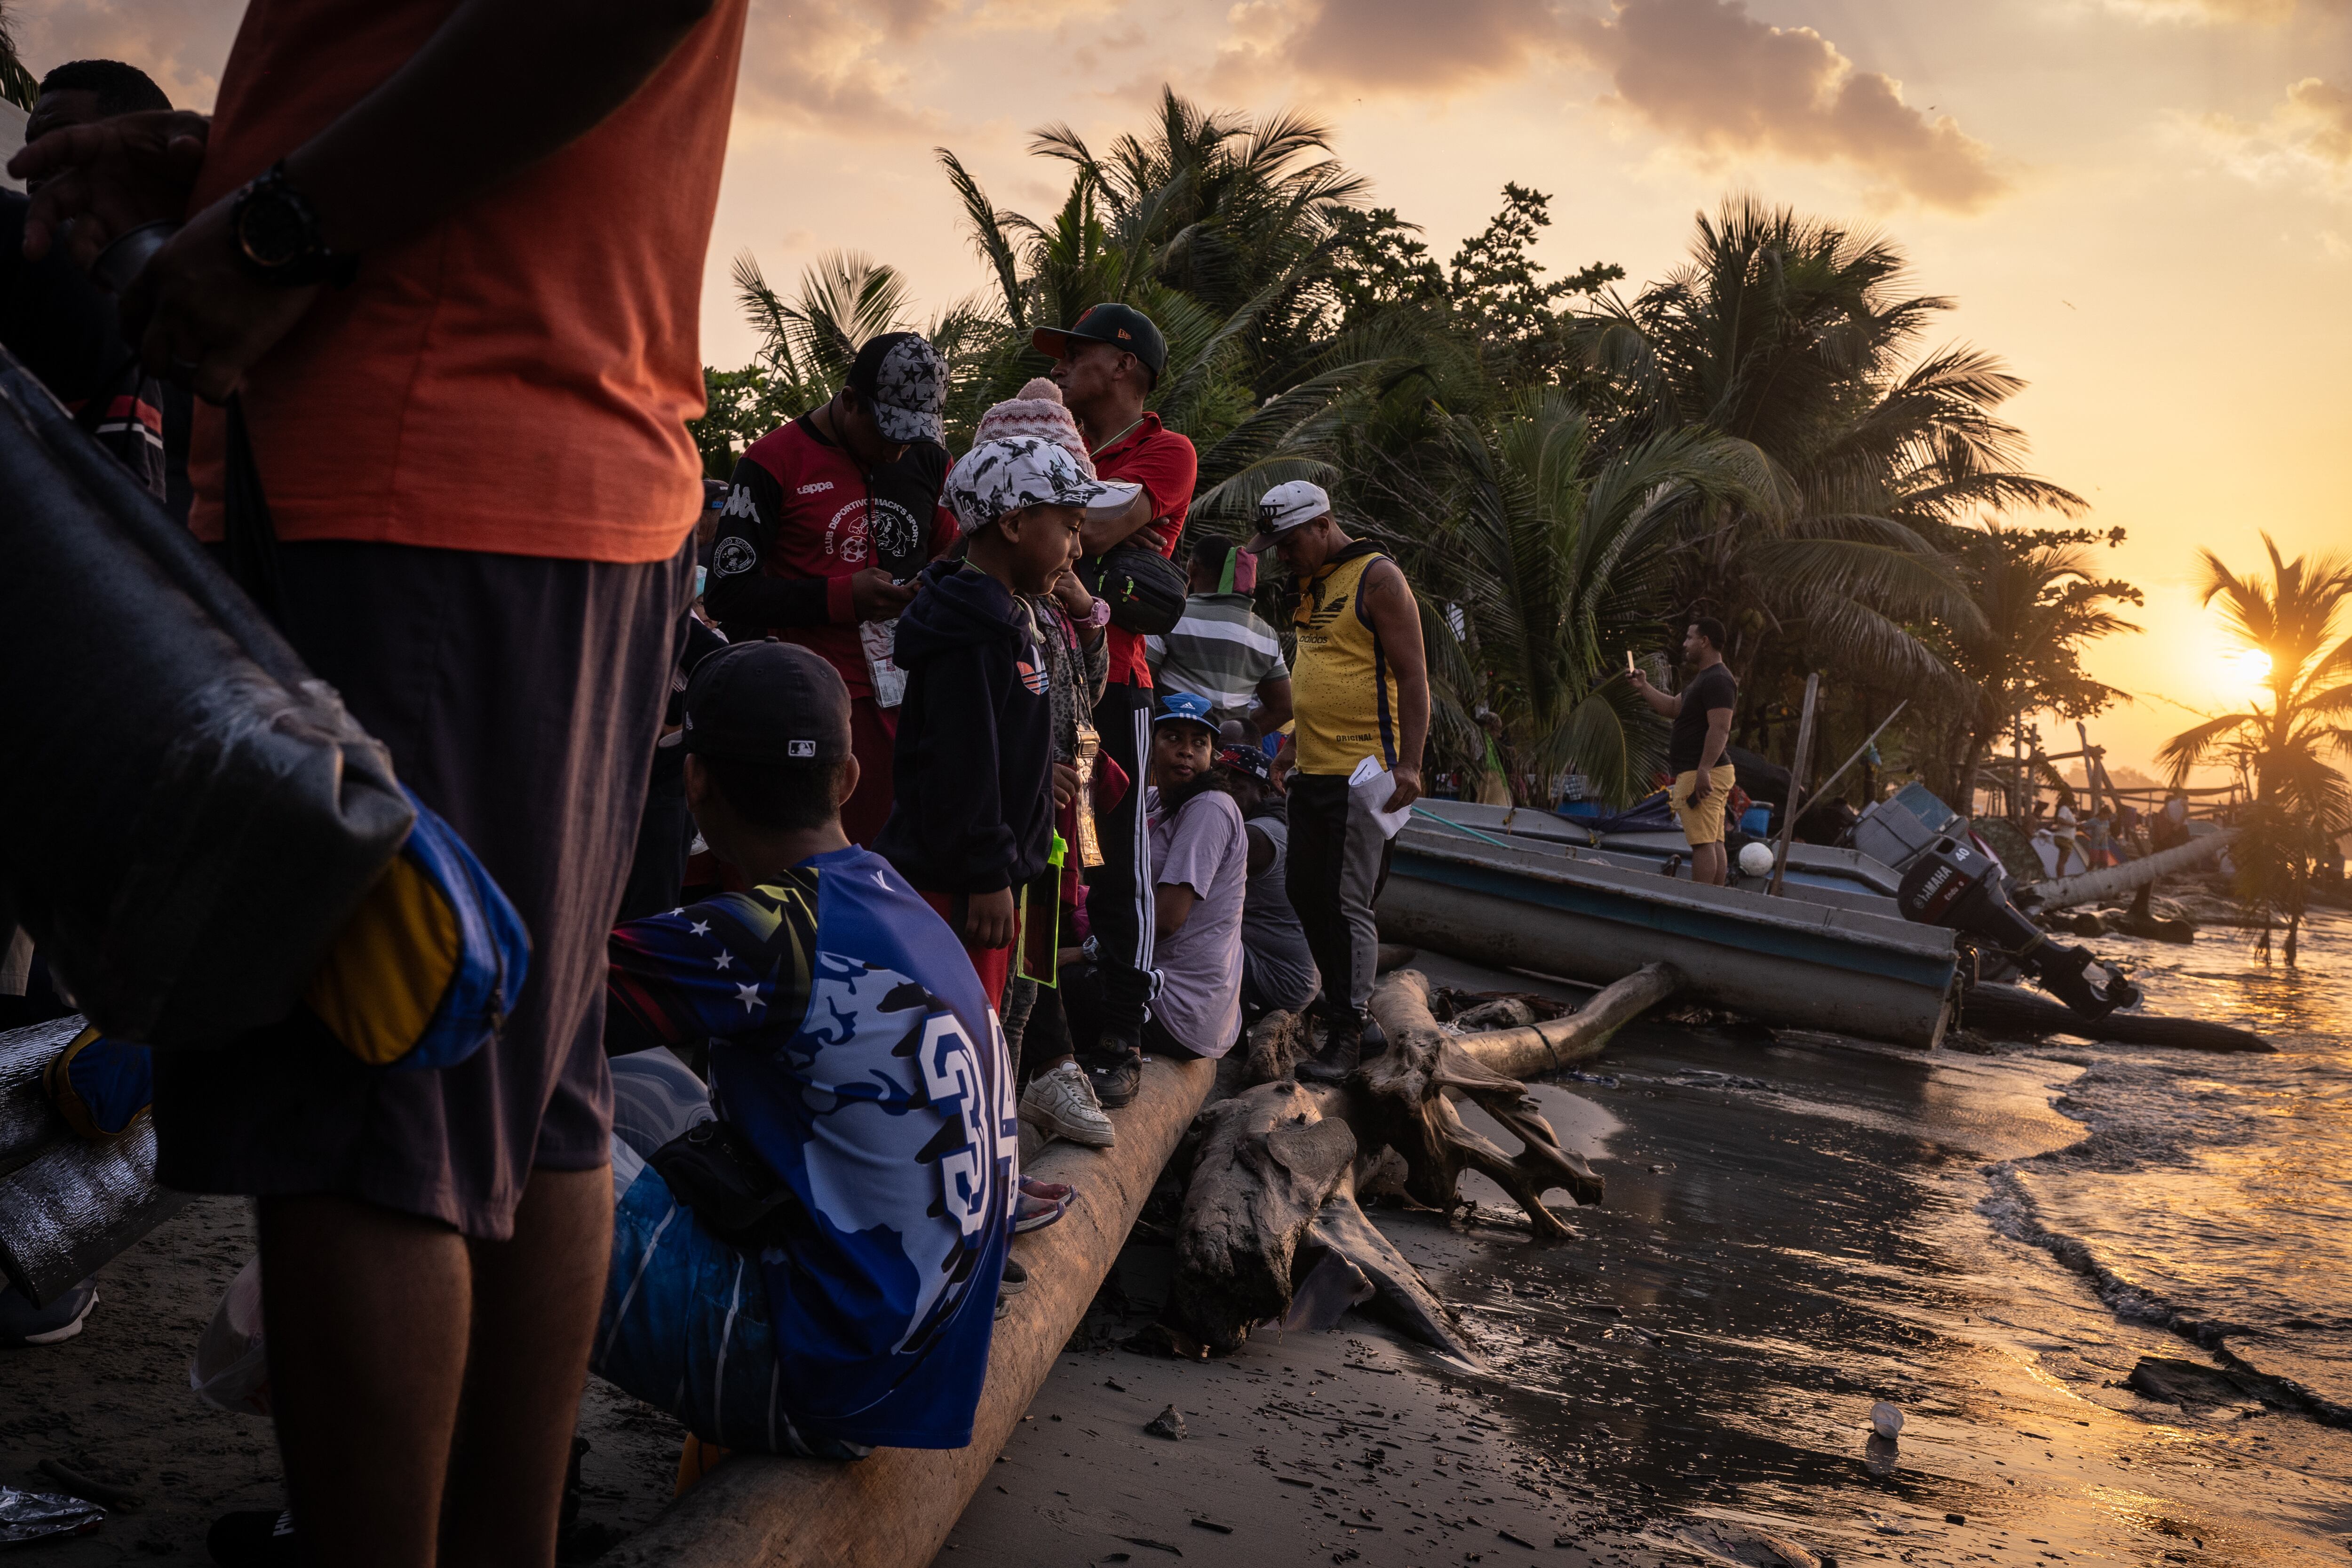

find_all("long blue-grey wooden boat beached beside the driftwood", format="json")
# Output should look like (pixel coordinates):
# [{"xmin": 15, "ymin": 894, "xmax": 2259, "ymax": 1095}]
[{"xmin": 1378, "ymin": 818, "xmax": 1959, "ymax": 1049}]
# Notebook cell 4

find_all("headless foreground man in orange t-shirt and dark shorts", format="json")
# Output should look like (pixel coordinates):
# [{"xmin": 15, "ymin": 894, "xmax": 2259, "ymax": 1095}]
[{"xmin": 12, "ymin": 0, "xmax": 746, "ymax": 1568}]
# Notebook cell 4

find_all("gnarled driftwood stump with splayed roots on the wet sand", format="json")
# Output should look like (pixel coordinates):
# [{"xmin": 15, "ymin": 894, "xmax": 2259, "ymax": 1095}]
[{"xmin": 1169, "ymin": 964, "xmax": 1679, "ymax": 1363}]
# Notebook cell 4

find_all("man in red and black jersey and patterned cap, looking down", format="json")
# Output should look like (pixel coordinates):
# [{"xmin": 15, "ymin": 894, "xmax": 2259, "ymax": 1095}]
[{"xmin": 703, "ymin": 332, "xmax": 955, "ymax": 846}]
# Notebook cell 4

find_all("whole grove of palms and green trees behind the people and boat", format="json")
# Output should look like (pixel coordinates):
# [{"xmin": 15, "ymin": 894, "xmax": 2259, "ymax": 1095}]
[{"xmin": 699, "ymin": 92, "xmax": 2138, "ymax": 822}]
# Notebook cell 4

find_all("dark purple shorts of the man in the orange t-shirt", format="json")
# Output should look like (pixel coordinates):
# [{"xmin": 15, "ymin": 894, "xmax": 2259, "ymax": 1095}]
[{"xmin": 155, "ymin": 541, "xmax": 694, "ymax": 1241}]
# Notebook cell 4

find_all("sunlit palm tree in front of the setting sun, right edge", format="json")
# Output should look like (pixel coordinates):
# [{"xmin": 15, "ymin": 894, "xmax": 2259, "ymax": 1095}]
[{"xmin": 2157, "ymin": 533, "xmax": 2352, "ymax": 964}]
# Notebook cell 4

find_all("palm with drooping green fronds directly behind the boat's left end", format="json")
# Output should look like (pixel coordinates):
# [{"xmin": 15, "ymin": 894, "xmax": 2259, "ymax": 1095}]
[{"xmin": 1371, "ymin": 388, "xmax": 1771, "ymax": 802}]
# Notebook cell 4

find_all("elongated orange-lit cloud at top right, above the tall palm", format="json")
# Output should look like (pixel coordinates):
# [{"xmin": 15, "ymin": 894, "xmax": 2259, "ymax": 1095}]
[{"xmin": 1578, "ymin": 0, "xmax": 2009, "ymax": 212}]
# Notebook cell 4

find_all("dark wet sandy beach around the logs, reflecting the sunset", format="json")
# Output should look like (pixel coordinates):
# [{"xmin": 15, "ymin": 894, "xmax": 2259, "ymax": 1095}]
[{"xmin": 0, "ymin": 955, "xmax": 2352, "ymax": 1568}]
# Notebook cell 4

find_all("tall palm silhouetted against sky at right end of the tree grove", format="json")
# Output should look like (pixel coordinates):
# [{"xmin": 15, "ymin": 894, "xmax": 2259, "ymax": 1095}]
[{"xmin": 1583, "ymin": 198, "xmax": 2084, "ymax": 693}]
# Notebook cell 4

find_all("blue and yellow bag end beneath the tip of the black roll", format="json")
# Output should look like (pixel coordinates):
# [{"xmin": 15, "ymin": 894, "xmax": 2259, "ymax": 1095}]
[{"xmin": 303, "ymin": 785, "xmax": 532, "ymax": 1067}]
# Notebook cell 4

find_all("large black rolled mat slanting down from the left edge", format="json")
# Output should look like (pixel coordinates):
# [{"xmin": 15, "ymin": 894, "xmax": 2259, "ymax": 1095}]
[{"xmin": 0, "ymin": 350, "xmax": 414, "ymax": 1046}]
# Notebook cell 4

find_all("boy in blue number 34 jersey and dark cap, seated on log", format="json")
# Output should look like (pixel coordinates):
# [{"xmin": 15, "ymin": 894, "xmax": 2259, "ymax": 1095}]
[{"xmin": 593, "ymin": 642, "xmax": 1018, "ymax": 1457}]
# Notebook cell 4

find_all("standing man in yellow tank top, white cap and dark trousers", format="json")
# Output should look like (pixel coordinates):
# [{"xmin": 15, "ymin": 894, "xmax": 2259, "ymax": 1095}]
[{"xmin": 1247, "ymin": 479, "xmax": 1430, "ymax": 1079}]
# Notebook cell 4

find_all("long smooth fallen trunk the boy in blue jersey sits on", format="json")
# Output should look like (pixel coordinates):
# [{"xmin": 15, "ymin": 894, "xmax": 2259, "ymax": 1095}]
[{"xmin": 600, "ymin": 1060, "xmax": 1216, "ymax": 1568}]
